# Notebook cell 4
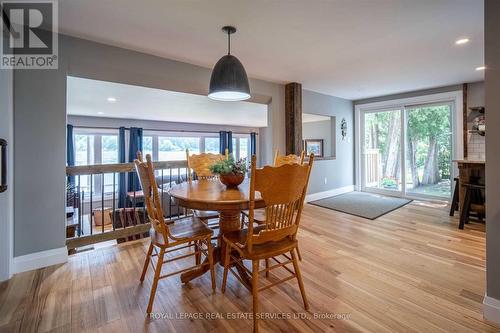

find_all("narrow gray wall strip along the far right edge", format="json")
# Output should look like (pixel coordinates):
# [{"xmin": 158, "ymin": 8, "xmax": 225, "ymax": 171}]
[{"xmin": 484, "ymin": 0, "xmax": 500, "ymax": 300}]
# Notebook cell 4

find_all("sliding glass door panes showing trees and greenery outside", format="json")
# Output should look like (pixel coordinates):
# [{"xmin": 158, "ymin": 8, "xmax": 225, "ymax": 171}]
[{"xmin": 360, "ymin": 103, "xmax": 453, "ymax": 199}]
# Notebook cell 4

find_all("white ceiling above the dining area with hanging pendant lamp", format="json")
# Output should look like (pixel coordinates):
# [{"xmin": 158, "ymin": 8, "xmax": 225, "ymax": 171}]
[{"xmin": 59, "ymin": 0, "xmax": 484, "ymax": 99}]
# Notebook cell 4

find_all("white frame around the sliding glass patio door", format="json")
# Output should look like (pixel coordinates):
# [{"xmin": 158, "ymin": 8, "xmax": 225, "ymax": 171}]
[{"xmin": 354, "ymin": 90, "xmax": 464, "ymax": 200}]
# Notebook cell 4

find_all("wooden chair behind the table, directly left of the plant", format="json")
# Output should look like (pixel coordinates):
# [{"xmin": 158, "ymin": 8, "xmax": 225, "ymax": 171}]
[{"xmin": 186, "ymin": 149, "xmax": 227, "ymax": 224}]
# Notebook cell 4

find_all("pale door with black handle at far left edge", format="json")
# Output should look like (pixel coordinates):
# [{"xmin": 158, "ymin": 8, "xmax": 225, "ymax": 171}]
[{"xmin": 0, "ymin": 33, "xmax": 14, "ymax": 281}]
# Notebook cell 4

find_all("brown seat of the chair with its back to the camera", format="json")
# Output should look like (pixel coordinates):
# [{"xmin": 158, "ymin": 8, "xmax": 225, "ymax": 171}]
[{"xmin": 223, "ymin": 226, "xmax": 297, "ymax": 260}]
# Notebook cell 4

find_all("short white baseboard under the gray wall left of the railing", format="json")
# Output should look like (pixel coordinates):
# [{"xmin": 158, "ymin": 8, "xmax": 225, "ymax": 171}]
[{"xmin": 13, "ymin": 246, "xmax": 68, "ymax": 274}]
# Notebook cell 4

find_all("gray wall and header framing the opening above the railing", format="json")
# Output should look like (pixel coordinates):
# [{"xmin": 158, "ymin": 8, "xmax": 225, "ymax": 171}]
[{"xmin": 14, "ymin": 36, "xmax": 285, "ymax": 256}]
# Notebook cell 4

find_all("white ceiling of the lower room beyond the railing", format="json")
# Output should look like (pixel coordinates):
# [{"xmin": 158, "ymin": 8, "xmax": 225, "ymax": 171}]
[{"xmin": 66, "ymin": 77, "xmax": 267, "ymax": 127}]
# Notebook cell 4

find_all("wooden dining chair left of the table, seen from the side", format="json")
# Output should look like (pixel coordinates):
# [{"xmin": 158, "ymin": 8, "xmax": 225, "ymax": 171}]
[{"xmin": 134, "ymin": 152, "xmax": 215, "ymax": 314}]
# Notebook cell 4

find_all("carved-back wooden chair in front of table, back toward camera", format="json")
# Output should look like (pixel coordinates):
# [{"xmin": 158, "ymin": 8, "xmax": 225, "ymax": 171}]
[{"xmin": 222, "ymin": 154, "xmax": 314, "ymax": 332}]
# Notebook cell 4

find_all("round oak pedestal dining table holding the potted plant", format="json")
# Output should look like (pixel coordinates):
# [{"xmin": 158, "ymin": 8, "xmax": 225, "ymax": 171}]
[{"xmin": 169, "ymin": 179, "xmax": 264, "ymax": 288}]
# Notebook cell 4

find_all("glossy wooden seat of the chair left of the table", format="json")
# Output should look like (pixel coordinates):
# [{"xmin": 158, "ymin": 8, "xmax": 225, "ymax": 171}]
[{"xmin": 149, "ymin": 216, "xmax": 213, "ymax": 247}]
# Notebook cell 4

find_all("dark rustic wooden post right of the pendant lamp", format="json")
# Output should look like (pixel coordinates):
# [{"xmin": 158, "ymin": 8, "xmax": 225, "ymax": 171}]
[{"xmin": 285, "ymin": 82, "xmax": 302, "ymax": 155}]
